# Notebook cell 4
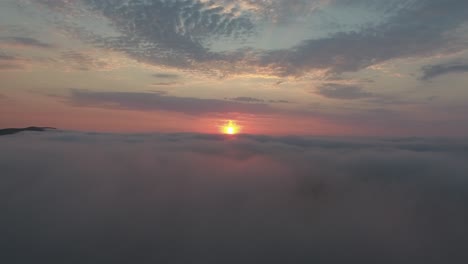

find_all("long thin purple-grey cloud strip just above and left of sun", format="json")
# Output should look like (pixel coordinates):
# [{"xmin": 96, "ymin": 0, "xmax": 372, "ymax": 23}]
[{"xmin": 69, "ymin": 89, "xmax": 277, "ymax": 115}]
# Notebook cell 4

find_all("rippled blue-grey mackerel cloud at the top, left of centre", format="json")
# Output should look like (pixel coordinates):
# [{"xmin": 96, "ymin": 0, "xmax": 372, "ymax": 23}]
[{"xmin": 85, "ymin": 0, "xmax": 253, "ymax": 67}]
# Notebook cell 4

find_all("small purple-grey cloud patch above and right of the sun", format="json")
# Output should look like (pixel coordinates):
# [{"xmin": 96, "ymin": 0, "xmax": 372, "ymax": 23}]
[{"xmin": 318, "ymin": 83, "xmax": 374, "ymax": 100}]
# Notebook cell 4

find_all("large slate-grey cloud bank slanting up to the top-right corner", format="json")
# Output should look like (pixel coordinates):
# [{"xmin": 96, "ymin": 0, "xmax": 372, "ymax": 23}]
[{"xmin": 260, "ymin": 0, "xmax": 468, "ymax": 75}]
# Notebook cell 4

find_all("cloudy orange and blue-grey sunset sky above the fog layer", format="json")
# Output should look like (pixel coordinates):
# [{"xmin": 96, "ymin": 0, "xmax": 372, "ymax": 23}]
[{"xmin": 0, "ymin": 0, "xmax": 468, "ymax": 136}]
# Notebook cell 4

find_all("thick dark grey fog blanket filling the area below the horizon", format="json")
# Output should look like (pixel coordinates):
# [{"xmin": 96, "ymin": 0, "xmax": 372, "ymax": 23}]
[{"xmin": 0, "ymin": 131, "xmax": 468, "ymax": 264}]
